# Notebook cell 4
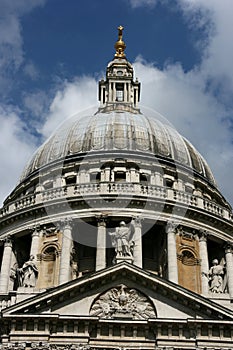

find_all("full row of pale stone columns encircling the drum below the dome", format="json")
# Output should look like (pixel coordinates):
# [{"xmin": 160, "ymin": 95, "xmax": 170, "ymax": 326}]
[{"xmin": 0, "ymin": 216, "xmax": 233, "ymax": 299}]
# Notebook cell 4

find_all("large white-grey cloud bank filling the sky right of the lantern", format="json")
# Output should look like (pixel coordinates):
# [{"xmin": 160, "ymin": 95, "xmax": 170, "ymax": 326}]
[{"xmin": 127, "ymin": 0, "xmax": 233, "ymax": 203}]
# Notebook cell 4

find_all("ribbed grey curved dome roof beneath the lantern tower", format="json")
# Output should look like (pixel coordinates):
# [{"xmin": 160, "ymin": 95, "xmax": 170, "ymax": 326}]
[{"xmin": 20, "ymin": 109, "xmax": 216, "ymax": 185}]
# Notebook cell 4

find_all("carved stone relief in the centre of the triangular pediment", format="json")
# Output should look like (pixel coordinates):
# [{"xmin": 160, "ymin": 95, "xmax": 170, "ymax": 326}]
[{"xmin": 90, "ymin": 284, "xmax": 157, "ymax": 320}]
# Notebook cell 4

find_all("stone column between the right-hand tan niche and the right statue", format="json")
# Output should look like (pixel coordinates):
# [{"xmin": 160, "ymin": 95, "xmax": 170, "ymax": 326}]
[{"xmin": 199, "ymin": 231, "xmax": 209, "ymax": 296}]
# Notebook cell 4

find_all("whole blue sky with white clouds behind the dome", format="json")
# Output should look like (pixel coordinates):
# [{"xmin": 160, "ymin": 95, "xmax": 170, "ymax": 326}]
[{"xmin": 0, "ymin": 0, "xmax": 233, "ymax": 208}]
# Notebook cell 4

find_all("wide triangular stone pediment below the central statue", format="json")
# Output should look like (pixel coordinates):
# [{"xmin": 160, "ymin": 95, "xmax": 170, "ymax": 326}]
[{"xmin": 2, "ymin": 262, "xmax": 233, "ymax": 320}]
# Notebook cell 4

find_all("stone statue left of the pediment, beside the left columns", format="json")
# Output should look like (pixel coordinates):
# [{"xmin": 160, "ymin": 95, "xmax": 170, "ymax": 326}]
[{"xmin": 18, "ymin": 255, "xmax": 38, "ymax": 287}]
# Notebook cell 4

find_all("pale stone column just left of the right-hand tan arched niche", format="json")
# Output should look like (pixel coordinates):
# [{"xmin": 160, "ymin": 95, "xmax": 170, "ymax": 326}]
[{"xmin": 166, "ymin": 222, "xmax": 178, "ymax": 283}]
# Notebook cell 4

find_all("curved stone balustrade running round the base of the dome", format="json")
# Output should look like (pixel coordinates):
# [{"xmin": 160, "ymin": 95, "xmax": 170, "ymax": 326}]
[{"xmin": 0, "ymin": 182, "xmax": 232, "ymax": 221}]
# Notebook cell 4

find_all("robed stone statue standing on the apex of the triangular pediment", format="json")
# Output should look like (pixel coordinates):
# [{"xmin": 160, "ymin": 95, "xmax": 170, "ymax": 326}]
[{"xmin": 109, "ymin": 221, "xmax": 134, "ymax": 258}]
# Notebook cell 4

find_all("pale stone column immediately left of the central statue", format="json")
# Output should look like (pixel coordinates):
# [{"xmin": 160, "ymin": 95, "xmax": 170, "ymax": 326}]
[{"xmin": 96, "ymin": 217, "xmax": 106, "ymax": 271}]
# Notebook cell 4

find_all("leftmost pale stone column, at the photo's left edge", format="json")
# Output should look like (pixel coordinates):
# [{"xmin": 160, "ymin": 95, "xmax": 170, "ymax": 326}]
[{"xmin": 0, "ymin": 237, "xmax": 12, "ymax": 294}]
